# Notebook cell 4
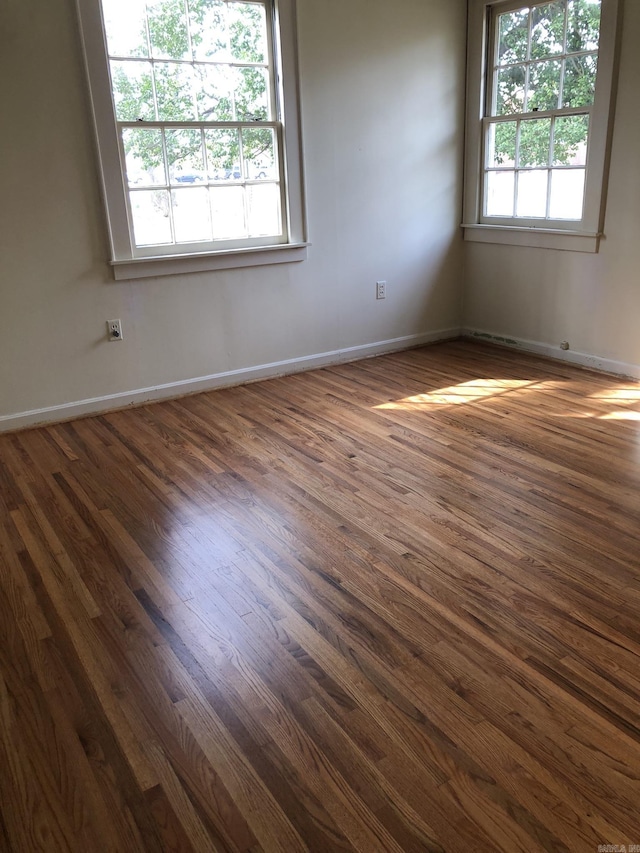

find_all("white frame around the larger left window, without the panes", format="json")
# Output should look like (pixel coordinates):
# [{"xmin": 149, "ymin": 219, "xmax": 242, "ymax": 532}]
[{"xmin": 77, "ymin": 0, "xmax": 308, "ymax": 279}]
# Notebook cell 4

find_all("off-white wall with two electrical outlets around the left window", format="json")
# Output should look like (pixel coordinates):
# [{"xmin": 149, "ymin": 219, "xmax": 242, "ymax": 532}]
[{"xmin": 0, "ymin": 0, "xmax": 466, "ymax": 427}]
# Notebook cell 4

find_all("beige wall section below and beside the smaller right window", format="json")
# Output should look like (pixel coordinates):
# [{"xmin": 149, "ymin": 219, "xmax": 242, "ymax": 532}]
[{"xmin": 464, "ymin": 0, "xmax": 640, "ymax": 374}]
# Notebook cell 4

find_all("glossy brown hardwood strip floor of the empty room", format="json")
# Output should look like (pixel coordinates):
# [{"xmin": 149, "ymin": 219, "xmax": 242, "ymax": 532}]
[{"xmin": 0, "ymin": 342, "xmax": 640, "ymax": 853}]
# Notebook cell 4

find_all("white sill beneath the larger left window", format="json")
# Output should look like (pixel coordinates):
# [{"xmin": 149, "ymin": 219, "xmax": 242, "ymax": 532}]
[{"xmin": 111, "ymin": 243, "xmax": 309, "ymax": 281}]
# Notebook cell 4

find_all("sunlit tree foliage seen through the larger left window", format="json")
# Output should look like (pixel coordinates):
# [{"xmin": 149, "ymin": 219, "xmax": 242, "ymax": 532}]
[{"xmin": 111, "ymin": 0, "xmax": 275, "ymax": 182}]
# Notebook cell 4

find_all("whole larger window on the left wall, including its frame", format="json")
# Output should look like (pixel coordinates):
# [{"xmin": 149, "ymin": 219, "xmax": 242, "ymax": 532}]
[{"xmin": 78, "ymin": 0, "xmax": 305, "ymax": 278}]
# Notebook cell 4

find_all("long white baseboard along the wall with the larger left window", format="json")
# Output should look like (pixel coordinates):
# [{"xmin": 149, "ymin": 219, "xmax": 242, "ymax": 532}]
[{"xmin": 0, "ymin": 329, "xmax": 461, "ymax": 432}]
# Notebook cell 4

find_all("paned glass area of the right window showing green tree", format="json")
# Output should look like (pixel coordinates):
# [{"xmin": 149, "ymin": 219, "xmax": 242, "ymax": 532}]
[{"xmin": 485, "ymin": 0, "xmax": 602, "ymax": 219}]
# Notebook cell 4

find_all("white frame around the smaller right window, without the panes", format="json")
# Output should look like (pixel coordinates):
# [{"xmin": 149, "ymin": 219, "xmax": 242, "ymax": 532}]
[{"xmin": 462, "ymin": 0, "xmax": 621, "ymax": 252}]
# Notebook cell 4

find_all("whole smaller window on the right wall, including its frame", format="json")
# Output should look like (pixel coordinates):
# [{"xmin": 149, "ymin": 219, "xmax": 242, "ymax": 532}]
[{"xmin": 465, "ymin": 0, "xmax": 617, "ymax": 251}]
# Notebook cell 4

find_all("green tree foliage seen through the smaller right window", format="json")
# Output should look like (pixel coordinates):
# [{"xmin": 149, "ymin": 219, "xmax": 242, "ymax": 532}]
[{"xmin": 493, "ymin": 0, "xmax": 601, "ymax": 166}]
